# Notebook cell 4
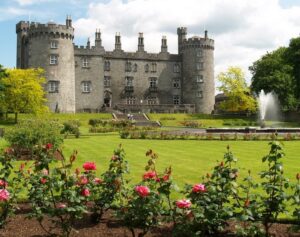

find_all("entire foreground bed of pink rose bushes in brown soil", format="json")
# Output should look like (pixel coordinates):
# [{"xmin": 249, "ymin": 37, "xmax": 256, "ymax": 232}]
[{"xmin": 0, "ymin": 142, "xmax": 300, "ymax": 237}]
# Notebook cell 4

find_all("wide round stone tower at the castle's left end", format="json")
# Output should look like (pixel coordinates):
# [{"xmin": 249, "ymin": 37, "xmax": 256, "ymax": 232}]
[{"xmin": 27, "ymin": 17, "xmax": 75, "ymax": 113}]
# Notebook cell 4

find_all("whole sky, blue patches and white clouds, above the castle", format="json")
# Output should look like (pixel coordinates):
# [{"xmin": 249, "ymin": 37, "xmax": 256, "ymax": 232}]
[{"xmin": 0, "ymin": 0, "xmax": 300, "ymax": 82}]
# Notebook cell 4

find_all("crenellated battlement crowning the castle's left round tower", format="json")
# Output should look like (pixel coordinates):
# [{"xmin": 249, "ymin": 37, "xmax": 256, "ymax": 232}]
[{"xmin": 16, "ymin": 21, "xmax": 74, "ymax": 39}]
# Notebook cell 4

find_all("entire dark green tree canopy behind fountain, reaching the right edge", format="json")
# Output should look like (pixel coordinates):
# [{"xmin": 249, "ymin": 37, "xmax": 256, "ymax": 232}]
[{"xmin": 249, "ymin": 38, "xmax": 300, "ymax": 110}]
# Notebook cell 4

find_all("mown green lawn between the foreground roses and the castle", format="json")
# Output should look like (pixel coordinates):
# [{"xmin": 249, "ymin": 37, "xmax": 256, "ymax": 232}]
[{"xmin": 60, "ymin": 134, "xmax": 300, "ymax": 187}]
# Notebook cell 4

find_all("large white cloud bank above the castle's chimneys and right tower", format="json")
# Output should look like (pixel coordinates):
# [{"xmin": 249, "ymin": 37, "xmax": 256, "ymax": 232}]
[{"xmin": 72, "ymin": 0, "xmax": 300, "ymax": 90}]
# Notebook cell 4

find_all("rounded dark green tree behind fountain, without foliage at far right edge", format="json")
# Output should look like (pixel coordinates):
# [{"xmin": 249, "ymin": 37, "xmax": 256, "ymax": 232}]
[{"xmin": 249, "ymin": 47, "xmax": 300, "ymax": 110}]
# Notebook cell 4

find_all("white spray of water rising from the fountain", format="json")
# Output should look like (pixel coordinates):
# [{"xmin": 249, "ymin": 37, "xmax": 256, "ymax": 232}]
[{"xmin": 258, "ymin": 90, "xmax": 280, "ymax": 128}]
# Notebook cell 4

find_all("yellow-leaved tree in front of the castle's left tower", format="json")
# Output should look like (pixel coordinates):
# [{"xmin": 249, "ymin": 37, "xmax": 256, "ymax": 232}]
[{"xmin": 2, "ymin": 69, "xmax": 48, "ymax": 123}]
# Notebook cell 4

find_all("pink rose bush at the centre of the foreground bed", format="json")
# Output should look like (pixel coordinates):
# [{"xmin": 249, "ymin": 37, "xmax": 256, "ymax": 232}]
[{"xmin": 119, "ymin": 150, "xmax": 173, "ymax": 237}]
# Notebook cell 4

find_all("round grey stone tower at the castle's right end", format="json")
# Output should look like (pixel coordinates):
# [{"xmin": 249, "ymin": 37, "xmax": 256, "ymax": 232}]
[{"xmin": 177, "ymin": 28, "xmax": 215, "ymax": 114}]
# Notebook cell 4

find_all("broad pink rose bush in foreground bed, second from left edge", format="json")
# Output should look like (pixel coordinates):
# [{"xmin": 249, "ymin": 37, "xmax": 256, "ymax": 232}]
[{"xmin": 20, "ymin": 146, "xmax": 95, "ymax": 236}]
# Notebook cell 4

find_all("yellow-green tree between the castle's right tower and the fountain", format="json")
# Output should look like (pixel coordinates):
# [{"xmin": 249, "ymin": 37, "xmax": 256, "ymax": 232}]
[{"xmin": 218, "ymin": 67, "xmax": 257, "ymax": 112}]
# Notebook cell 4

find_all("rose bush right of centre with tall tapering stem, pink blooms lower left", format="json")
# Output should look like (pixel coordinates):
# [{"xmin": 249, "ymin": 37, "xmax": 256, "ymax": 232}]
[{"xmin": 174, "ymin": 147, "xmax": 238, "ymax": 236}]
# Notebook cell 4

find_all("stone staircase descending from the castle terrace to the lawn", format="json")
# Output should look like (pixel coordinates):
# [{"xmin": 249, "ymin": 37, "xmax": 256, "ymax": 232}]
[{"xmin": 113, "ymin": 113, "xmax": 161, "ymax": 127}]
